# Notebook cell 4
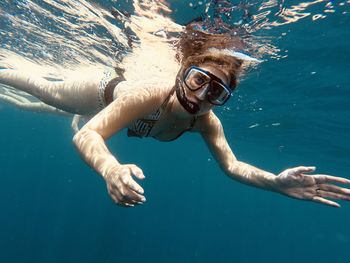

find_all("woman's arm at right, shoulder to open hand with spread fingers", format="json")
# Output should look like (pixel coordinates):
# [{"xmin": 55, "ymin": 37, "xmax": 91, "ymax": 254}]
[{"xmin": 198, "ymin": 112, "xmax": 350, "ymax": 207}]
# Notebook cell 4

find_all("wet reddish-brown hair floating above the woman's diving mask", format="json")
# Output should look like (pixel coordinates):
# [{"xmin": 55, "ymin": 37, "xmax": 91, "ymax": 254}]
[{"xmin": 176, "ymin": 23, "xmax": 244, "ymax": 87}]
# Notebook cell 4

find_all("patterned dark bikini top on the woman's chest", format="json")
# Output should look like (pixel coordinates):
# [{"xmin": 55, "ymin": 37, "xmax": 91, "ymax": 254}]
[{"xmin": 128, "ymin": 88, "xmax": 197, "ymax": 141}]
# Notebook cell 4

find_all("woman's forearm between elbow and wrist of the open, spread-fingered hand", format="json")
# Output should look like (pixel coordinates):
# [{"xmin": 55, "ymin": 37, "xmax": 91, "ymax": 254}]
[{"xmin": 225, "ymin": 160, "xmax": 276, "ymax": 191}]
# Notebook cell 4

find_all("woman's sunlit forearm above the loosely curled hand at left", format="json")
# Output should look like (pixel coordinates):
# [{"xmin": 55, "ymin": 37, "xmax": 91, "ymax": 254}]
[{"xmin": 73, "ymin": 128, "xmax": 120, "ymax": 178}]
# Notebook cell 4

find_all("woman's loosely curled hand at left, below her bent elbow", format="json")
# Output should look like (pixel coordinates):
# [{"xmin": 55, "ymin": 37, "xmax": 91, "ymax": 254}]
[{"xmin": 104, "ymin": 164, "xmax": 146, "ymax": 207}]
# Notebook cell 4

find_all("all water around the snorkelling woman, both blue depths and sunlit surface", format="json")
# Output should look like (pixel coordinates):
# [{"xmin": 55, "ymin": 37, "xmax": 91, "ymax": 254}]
[{"xmin": 0, "ymin": 0, "xmax": 350, "ymax": 263}]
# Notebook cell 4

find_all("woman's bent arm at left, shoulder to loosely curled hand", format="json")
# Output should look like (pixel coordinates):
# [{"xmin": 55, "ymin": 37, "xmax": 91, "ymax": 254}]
[{"xmin": 73, "ymin": 82, "xmax": 168, "ymax": 206}]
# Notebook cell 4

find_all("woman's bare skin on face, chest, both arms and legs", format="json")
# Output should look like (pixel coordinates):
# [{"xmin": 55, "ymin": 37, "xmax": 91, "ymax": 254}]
[{"xmin": 0, "ymin": 64, "xmax": 350, "ymax": 207}]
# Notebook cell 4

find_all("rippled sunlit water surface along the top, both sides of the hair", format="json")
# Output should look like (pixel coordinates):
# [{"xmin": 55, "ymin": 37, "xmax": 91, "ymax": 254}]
[{"xmin": 0, "ymin": 0, "xmax": 349, "ymax": 103}]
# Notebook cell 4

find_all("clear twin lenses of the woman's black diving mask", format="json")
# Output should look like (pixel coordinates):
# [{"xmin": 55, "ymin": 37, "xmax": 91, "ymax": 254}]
[{"xmin": 184, "ymin": 66, "xmax": 231, "ymax": 105}]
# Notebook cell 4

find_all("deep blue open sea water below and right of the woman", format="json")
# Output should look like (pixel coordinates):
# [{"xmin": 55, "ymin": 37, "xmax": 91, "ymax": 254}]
[{"xmin": 0, "ymin": 1, "xmax": 350, "ymax": 263}]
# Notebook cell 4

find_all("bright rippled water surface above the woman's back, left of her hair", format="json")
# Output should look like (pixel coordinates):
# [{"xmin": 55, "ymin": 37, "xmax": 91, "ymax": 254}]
[{"xmin": 0, "ymin": 0, "xmax": 182, "ymax": 103}]
